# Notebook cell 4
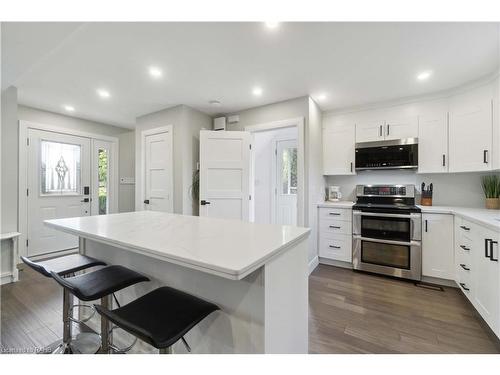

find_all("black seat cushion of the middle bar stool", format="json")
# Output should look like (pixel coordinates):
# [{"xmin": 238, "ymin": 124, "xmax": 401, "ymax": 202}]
[{"xmin": 52, "ymin": 265, "xmax": 149, "ymax": 301}]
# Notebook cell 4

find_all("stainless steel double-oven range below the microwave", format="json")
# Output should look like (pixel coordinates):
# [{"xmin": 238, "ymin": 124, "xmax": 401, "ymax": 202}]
[{"xmin": 352, "ymin": 185, "xmax": 422, "ymax": 280}]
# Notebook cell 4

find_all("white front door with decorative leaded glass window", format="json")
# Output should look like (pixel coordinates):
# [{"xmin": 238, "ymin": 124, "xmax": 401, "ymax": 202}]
[{"xmin": 27, "ymin": 129, "xmax": 90, "ymax": 256}]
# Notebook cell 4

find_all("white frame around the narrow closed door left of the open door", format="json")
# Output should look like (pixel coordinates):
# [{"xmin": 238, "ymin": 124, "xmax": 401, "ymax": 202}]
[{"xmin": 139, "ymin": 125, "xmax": 175, "ymax": 213}]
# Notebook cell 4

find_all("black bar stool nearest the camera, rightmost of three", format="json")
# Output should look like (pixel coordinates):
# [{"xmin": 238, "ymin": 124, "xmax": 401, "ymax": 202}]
[{"xmin": 94, "ymin": 287, "xmax": 219, "ymax": 354}]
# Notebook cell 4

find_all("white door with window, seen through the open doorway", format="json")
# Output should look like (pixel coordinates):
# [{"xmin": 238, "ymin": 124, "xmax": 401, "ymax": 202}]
[{"xmin": 273, "ymin": 139, "xmax": 297, "ymax": 225}]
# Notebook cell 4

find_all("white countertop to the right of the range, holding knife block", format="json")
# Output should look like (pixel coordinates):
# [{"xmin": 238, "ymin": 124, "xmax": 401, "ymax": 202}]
[{"xmin": 418, "ymin": 205, "xmax": 500, "ymax": 232}]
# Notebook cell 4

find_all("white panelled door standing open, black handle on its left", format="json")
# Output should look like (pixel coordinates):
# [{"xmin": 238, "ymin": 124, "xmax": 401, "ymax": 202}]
[{"xmin": 200, "ymin": 130, "xmax": 251, "ymax": 221}]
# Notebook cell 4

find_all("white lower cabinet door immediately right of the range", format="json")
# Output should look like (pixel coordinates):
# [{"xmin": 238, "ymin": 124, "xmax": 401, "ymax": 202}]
[{"xmin": 422, "ymin": 214, "xmax": 455, "ymax": 280}]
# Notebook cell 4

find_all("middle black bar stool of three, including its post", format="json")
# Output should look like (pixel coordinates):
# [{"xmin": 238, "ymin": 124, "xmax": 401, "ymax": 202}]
[{"xmin": 51, "ymin": 265, "xmax": 149, "ymax": 353}]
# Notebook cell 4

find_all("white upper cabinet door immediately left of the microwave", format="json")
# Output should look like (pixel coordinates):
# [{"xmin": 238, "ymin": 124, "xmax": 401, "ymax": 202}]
[{"xmin": 323, "ymin": 124, "xmax": 355, "ymax": 175}]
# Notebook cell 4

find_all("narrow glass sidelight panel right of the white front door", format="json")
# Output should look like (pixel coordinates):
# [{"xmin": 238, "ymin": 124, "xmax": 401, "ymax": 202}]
[{"xmin": 91, "ymin": 139, "xmax": 117, "ymax": 215}]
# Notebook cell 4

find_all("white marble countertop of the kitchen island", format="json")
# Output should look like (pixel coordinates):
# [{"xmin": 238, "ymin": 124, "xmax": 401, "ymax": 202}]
[{"xmin": 45, "ymin": 211, "xmax": 310, "ymax": 280}]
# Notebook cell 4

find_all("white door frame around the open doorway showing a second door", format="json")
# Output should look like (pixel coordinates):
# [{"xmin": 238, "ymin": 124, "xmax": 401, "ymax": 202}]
[{"xmin": 245, "ymin": 117, "xmax": 306, "ymax": 226}]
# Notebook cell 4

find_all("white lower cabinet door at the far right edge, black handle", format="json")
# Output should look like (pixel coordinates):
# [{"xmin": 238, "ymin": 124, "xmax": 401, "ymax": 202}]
[{"xmin": 472, "ymin": 226, "xmax": 500, "ymax": 333}]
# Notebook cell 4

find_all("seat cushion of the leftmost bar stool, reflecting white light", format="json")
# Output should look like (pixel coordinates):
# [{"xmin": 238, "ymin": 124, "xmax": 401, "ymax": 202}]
[{"xmin": 21, "ymin": 254, "xmax": 106, "ymax": 277}]
